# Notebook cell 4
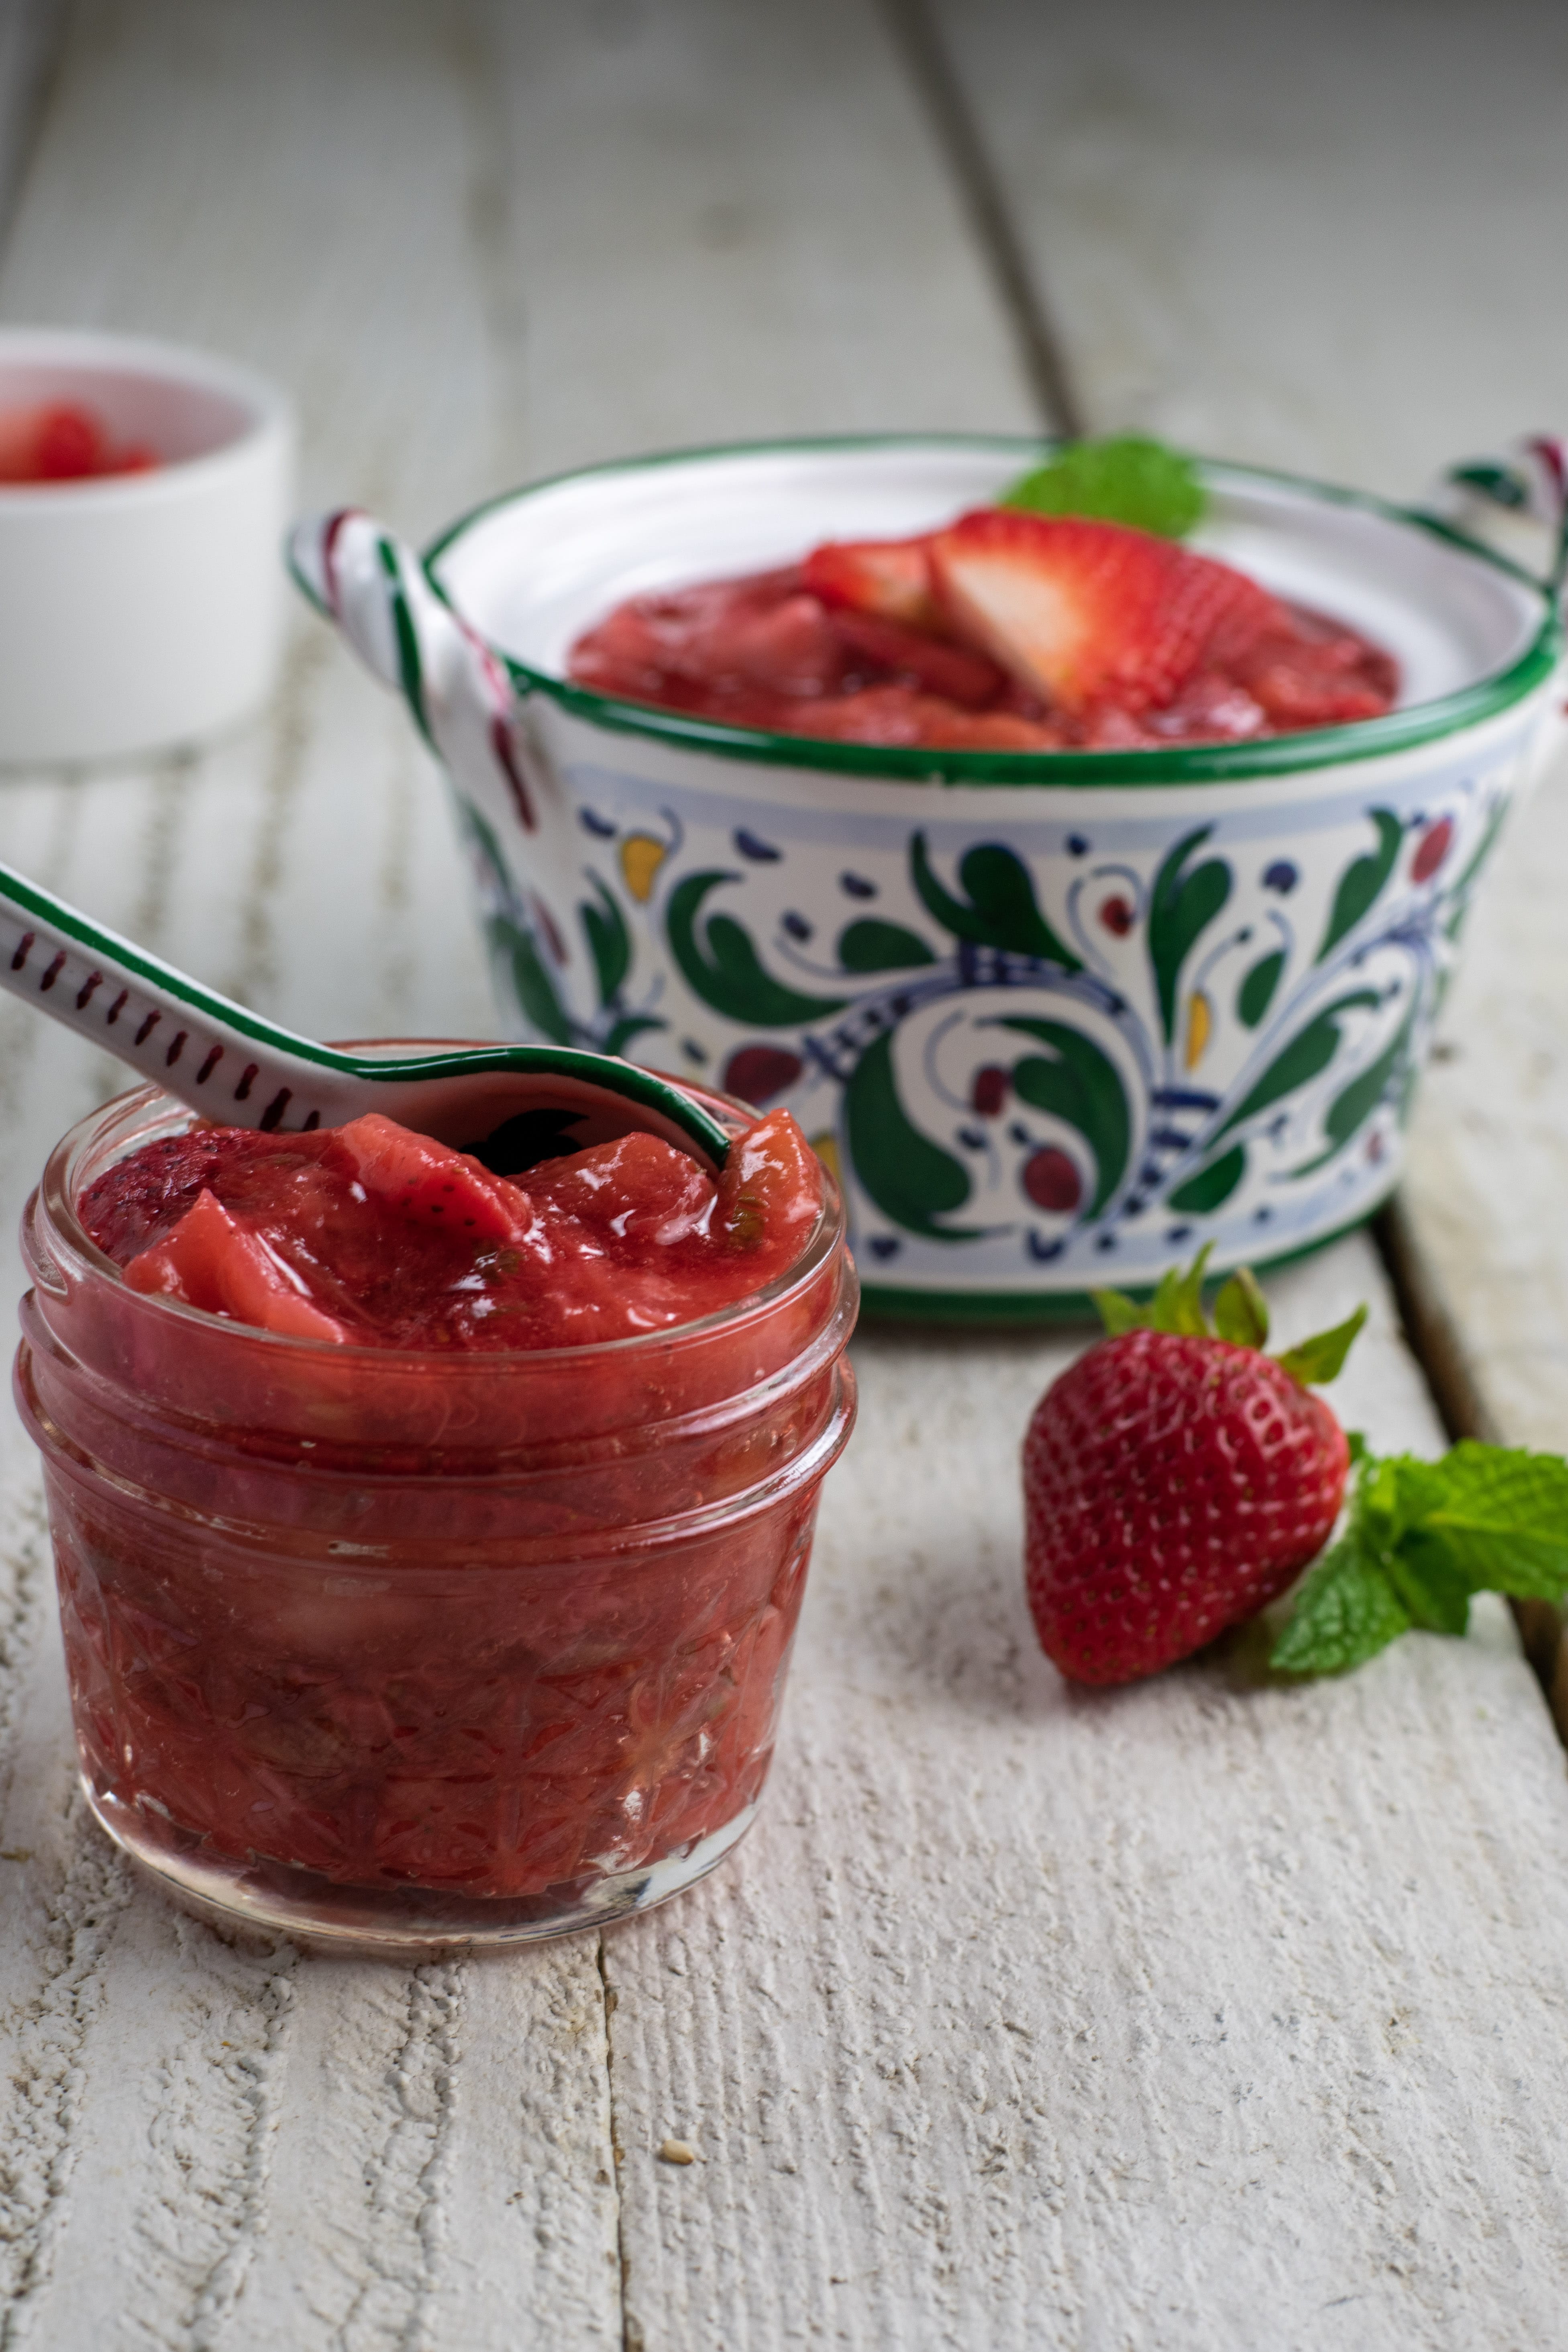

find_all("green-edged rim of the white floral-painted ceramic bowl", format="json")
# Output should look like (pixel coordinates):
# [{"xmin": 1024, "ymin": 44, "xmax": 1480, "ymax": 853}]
[{"xmin": 421, "ymin": 433, "xmax": 1563, "ymax": 786}]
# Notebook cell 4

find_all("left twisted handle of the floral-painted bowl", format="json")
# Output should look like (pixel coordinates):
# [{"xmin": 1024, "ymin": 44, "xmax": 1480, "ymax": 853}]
[{"xmin": 289, "ymin": 505, "xmax": 538, "ymax": 833}]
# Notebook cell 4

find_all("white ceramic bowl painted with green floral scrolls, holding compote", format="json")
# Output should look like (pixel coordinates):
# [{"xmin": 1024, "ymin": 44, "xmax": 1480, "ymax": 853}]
[{"xmin": 294, "ymin": 438, "xmax": 1561, "ymax": 1317}]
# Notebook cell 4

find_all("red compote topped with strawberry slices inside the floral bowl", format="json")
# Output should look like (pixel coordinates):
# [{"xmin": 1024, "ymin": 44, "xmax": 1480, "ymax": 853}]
[{"xmin": 569, "ymin": 508, "xmax": 1399, "ymax": 750}]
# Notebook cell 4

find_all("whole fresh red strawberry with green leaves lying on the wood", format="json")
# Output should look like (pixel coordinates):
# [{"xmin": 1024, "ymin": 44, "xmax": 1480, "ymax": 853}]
[{"xmin": 1023, "ymin": 1251, "xmax": 1366, "ymax": 1684}]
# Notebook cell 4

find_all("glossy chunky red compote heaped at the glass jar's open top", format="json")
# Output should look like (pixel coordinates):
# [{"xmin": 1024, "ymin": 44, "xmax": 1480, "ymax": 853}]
[{"xmin": 80, "ymin": 1110, "xmax": 823, "ymax": 1348}]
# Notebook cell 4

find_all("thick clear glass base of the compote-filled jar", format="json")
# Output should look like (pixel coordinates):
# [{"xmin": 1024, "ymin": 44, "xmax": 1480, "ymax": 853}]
[{"xmin": 82, "ymin": 1776, "xmax": 757, "ymax": 1959}]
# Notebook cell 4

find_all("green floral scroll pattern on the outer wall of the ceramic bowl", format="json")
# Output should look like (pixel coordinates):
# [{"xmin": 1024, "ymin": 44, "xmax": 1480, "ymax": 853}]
[{"xmin": 465, "ymin": 724, "xmax": 1533, "ymax": 1294}]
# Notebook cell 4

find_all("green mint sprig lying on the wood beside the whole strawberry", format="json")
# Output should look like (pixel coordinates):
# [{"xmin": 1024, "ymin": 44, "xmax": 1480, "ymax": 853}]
[{"xmin": 1269, "ymin": 1437, "xmax": 1568, "ymax": 1675}]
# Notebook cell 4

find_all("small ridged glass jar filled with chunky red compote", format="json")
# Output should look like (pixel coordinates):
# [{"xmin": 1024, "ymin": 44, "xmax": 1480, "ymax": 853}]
[{"xmin": 16, "ymin": 1091, "xmax": 853, "ymax": 1945}]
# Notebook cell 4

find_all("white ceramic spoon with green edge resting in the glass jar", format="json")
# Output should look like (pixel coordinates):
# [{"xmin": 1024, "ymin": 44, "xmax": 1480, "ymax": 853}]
[{"xmin": 0, "ymin": 866, "xmax": 729, "ymax": 1176}]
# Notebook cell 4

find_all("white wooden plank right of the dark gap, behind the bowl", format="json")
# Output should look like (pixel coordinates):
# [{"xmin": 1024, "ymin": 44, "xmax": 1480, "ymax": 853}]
[{"xmin": 938, "ymin": 0, "xmax": 1568, "ymax": 1449}]
